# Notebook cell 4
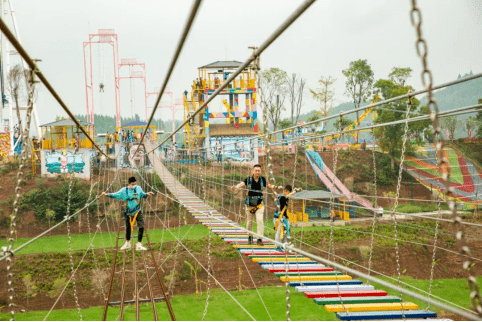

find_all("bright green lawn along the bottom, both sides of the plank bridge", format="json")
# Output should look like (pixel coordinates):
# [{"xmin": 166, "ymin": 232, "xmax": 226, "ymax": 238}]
[{"xmin": 0, "ymin": 276, "xmax": 482, "ymax": 321}]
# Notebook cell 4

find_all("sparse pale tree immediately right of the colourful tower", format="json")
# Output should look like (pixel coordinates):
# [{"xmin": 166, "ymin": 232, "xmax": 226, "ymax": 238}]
[{"xmin": 260, "ymin": 68, "xmax": 288, "ymax": 131}]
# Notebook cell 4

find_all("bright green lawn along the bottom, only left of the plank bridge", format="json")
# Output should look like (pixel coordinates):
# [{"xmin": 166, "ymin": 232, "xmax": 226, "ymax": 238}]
[{"xmin": 0, "ymin": 286, "xmax": 336, "ymax": 321}]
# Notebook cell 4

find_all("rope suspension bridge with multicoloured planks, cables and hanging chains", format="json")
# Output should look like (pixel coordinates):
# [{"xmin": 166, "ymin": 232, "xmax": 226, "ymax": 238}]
[{"xmin": 0, "ymin": 0, "xmax": 482, "ymax": 321}]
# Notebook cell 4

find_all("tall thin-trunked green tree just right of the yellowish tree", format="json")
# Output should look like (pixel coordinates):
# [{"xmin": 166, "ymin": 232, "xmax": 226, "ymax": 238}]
[{"xmin": 343, "ymin": 59, "xmax": 374, "ymax": 143}]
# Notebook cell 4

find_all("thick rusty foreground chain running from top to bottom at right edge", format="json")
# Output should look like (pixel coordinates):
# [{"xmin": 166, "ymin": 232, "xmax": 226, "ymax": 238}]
[{"xmin": 410, "ymin": 0, "xmax": 482, "ymax": 317}]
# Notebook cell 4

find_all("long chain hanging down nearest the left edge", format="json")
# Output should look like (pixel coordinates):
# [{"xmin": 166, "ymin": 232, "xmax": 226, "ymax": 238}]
[{"xmin": 5, "ymin": 68, "xmax": 36, "ymax": 321}]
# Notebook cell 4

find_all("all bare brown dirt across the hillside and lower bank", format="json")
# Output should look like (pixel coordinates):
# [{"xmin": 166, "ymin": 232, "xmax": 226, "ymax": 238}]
[{"xmin": 0, "ymin": 151, "xmax": 476, "ymax": 318}]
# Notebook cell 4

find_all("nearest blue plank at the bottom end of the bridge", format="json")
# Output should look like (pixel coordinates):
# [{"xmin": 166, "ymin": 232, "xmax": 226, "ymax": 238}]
[{"xmin": 336, "ymin": 310, "xmax": 437, "ymax": 321}]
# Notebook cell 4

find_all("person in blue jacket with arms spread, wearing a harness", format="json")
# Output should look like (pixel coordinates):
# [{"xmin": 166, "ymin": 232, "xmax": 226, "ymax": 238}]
[{"xmin": 102, "ymin": 177, "xmax": 154, "ymax": 250}]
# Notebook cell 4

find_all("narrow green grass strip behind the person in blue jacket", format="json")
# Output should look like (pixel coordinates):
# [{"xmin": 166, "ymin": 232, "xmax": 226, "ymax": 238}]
[{"xmin": 0, "ymin": 225, "xmax": 208, "ymax": 254}]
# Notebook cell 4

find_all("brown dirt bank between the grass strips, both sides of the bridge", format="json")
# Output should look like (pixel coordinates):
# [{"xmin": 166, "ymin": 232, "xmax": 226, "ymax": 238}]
[{"xmin": 0, "ymin": 215, "xmax": 482, "ymax": 318}]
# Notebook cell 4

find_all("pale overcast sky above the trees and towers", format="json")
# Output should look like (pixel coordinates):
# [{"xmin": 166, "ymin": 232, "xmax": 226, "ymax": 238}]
[{"xmin": 4, "ymin": 0, "xmax": 482, "ymax": 127}]
